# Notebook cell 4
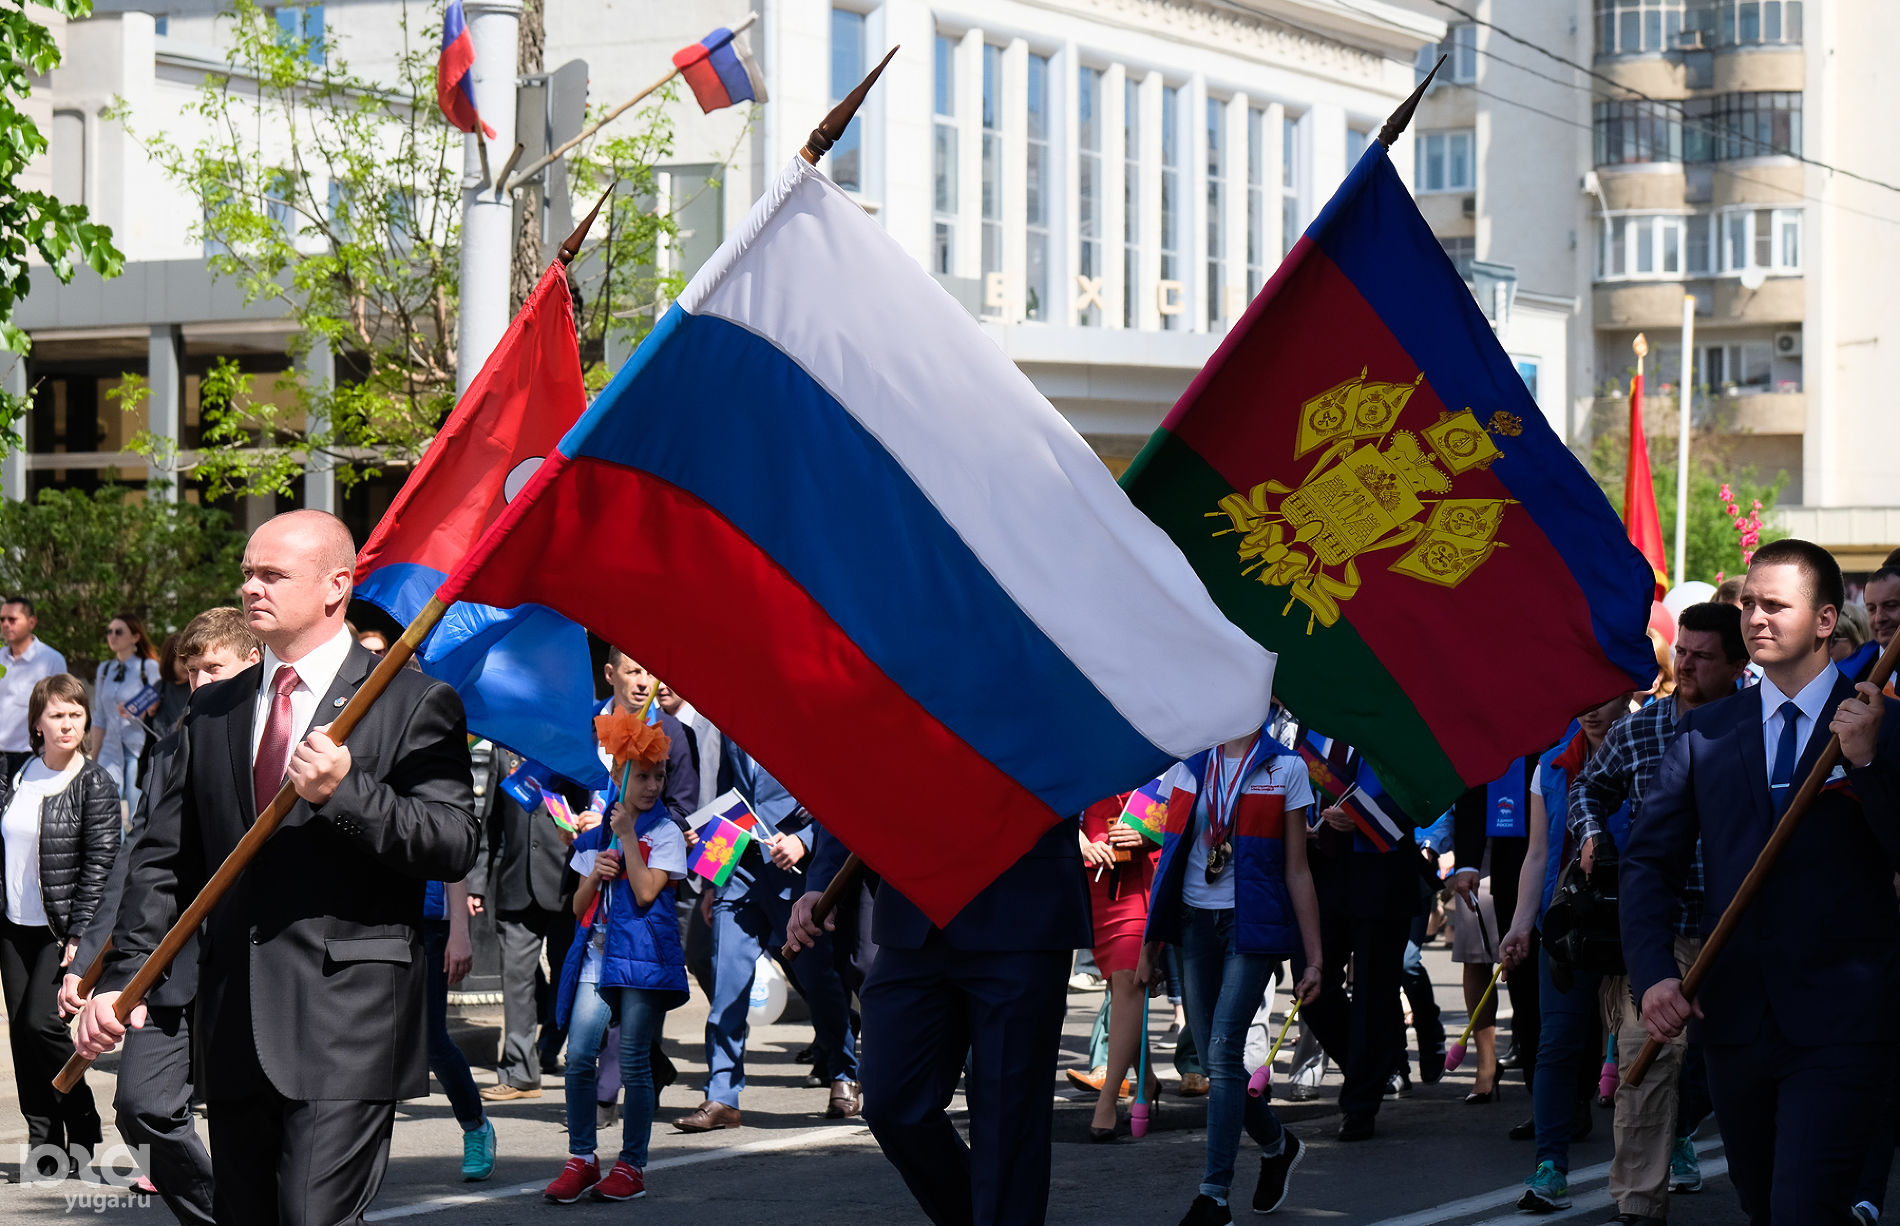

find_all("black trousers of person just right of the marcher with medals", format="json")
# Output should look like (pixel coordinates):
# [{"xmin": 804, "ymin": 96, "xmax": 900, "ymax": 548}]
[{"xmin": 1302, "ymin": 912, "xmax": 1412, "ymax": 1118}]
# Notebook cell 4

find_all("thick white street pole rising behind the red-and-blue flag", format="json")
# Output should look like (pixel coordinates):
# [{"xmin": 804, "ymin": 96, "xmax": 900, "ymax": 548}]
[{"xmin": 456, "ymin": 0, "xmax": 521, "ymax": 395}]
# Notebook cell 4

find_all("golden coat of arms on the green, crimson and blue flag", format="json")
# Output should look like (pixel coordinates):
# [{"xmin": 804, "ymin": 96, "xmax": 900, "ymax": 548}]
[{"xmin": 1208, "ymin": 371, "xmax": 1522, "ymax": 635}]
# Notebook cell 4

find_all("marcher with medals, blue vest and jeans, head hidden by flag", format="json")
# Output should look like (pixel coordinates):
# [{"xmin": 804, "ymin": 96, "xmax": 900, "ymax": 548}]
[{"xmin": 1136, "ymin": 730, "xmax": 1321, "ymax": 1226}]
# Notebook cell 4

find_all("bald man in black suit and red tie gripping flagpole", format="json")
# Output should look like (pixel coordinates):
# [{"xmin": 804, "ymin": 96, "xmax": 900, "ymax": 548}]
[{"xmin": 74, "ymin": 511, "xmax": 477, "ymax": 1226}]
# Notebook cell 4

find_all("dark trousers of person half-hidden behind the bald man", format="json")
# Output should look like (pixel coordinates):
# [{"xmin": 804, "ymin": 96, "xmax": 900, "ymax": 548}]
[{"xmin": 112, "ymin": 1006, "xmax": 215, "ymax": 1226}]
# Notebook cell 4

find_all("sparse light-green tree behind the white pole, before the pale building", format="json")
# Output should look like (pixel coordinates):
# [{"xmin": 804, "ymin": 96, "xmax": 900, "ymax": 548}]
[{"xmin": 116, "ymin": 0, "xmax": 718, "ymax": 496}]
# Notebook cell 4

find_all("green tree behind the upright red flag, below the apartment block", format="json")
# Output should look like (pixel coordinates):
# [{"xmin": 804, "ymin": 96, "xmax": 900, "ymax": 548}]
[{"xmin": 1590, "ymin": 428, "xmax": 1788, "ymax": 584}]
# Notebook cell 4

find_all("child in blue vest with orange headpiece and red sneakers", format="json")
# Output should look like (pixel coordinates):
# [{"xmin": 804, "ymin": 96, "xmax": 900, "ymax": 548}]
[{"xmin": 545, "ymin": 736, "xmax": 686, "ymax": 1205}]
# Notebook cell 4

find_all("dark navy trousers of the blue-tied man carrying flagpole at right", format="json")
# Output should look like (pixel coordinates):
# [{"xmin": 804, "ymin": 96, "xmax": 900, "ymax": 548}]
[{"xmin": 1704, "ymin": 1015, "xmax": 1894, "ymax": 1226}]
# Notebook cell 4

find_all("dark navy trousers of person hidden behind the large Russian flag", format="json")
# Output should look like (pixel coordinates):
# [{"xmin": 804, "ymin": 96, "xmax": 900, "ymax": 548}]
[{"xmin": 863, "ymin": 931, "xmax": 1072, "ymax": 1226}]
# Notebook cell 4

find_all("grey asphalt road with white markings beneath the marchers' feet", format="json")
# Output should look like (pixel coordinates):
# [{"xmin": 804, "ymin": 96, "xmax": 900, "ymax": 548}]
[{"xmin": 0, "ymin": 943, "xmax": 1793, "ymax": 1226}]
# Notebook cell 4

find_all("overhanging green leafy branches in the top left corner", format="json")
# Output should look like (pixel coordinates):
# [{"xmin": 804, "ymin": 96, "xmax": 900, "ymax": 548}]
[{"xmin": 0, "ymin": 0, "xmax": 125, "ymax": 454}]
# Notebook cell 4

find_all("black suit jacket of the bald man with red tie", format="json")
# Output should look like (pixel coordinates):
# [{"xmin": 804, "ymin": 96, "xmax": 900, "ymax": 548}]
[{"xmin": 101, "ymin": 646, "xmax": 477, "ymax": 1101}]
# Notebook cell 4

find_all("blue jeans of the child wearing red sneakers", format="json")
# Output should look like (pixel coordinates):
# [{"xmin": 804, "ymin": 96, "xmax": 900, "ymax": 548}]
[{"xmin": 566, "ymin": 983, "xmax": 667, "ymax": 1171}]
